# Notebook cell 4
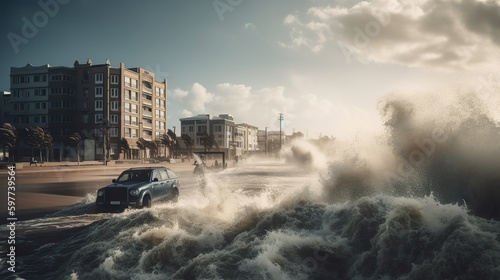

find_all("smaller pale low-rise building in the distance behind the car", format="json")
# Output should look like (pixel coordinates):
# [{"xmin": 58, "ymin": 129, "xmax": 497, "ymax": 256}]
[{"xmin": 180, "ymin": 114, "xmax": 259, "ymax": 157}]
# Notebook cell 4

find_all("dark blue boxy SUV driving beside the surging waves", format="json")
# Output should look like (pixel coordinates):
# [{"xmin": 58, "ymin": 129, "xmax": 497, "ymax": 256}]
[{"xmin": 96, "ymin": 167, "xmax": 180, "ymax": 208}]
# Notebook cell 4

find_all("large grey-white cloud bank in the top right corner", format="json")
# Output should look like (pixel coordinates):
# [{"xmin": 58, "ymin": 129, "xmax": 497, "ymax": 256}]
[{"xmin": 284, "ymin": 0, "xmax": 500, "ymax": 69}]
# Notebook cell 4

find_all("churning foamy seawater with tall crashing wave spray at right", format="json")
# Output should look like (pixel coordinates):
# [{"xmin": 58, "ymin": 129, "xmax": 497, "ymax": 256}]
[{"xmin": 0, "ymin": 90, "xmax": 500, "ymax": 279}]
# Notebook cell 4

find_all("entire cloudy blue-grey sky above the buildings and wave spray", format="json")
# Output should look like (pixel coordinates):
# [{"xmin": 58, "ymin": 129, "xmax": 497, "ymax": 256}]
[{"xmin": 0, "ymin": 0, "xmax": 500, "ymax": 139}]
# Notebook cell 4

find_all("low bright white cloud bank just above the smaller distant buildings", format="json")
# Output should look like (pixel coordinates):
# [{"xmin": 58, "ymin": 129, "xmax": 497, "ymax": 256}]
[{"xmin": 173, "ymin": 80, "xmax": 379, "ymax": 137}]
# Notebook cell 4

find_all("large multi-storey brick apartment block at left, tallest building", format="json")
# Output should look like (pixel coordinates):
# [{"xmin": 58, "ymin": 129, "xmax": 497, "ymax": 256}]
[{"xmin": 0, "ymin": 60, "xmax": 168, "ymax": 161}]
